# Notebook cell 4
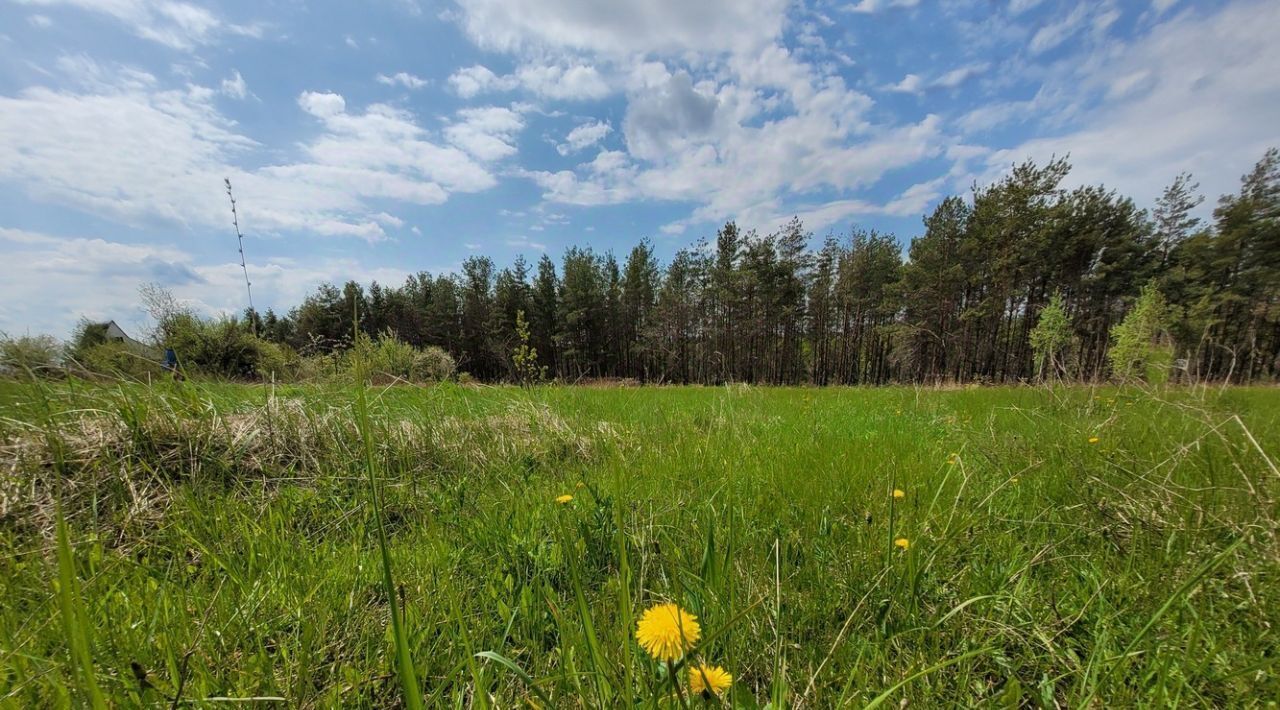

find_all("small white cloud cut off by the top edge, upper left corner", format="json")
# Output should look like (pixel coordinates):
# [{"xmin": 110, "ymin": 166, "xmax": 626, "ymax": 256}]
[{"xmin": 15, "ymin": 0, "xmax": 262, "ymax": 50}]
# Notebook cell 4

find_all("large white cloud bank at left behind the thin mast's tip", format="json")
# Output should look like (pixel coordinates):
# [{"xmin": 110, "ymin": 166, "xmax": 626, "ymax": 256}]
[{"xmin": 0, "ymin": 60, "xmax": 497, "ymax": 246}]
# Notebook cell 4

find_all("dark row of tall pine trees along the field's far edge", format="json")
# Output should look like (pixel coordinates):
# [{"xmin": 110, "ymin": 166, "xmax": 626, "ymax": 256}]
[{"xmin": 248, "ymin": 148, "xmax": 1280, "ymax": 385}]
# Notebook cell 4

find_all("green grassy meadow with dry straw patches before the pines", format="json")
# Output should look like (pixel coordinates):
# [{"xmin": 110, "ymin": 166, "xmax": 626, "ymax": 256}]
[{"xmin": 0, "ymin": 383, "xmax": 1280, "ymax": 707}]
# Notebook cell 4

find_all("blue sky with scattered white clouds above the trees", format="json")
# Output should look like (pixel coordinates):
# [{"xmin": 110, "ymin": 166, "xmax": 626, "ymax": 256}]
[{"xmin": 0, "ymin": 0, "xmax": 1280, "ymax": 336}]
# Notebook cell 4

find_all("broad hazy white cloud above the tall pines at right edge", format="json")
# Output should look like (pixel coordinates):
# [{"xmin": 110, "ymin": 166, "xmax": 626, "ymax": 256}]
[{"xmin": 988, "ymin": 1, "xmax": 1280, "ymax": 205}]
